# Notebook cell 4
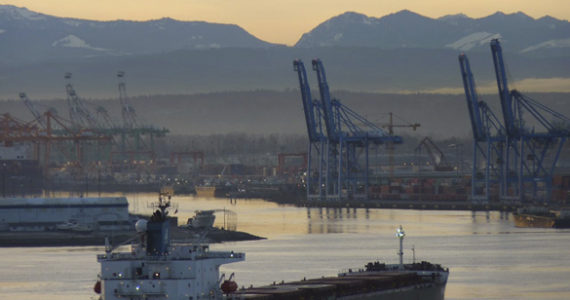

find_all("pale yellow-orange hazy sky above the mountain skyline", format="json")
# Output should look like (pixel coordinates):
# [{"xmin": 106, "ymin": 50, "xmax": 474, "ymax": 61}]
[{"xmin": 2, "ymin": 0, "xmax": 570, "ymax": 45}]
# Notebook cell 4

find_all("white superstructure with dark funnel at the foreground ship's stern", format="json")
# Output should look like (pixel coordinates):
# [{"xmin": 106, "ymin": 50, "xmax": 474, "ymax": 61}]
[{"xmin": 94, "ymin": 193, "xmax": 245, "ymax": 300}]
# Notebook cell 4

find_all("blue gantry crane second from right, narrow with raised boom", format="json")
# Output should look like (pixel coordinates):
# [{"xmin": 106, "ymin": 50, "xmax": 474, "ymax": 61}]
[{"xmin": 459, "ymin": 54, "xmax": 506, "ymax": 203}]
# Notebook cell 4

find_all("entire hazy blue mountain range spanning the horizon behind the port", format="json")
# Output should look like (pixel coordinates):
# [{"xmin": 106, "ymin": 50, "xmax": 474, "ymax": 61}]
[{"xmin": 0, "ymin": 5, "xmax": 570, "ymax": 99}]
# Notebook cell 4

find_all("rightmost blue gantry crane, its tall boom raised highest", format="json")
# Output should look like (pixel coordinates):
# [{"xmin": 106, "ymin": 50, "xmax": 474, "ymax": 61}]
[{"xmin": 490, "ymin": 39, "xmax": 570, "ymax": 202}]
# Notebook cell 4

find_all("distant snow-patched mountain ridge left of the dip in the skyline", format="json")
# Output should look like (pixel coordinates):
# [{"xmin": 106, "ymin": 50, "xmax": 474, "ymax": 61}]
[{"xmin": 0, "ymin": 5, "xmax": 272, "ymax": 62}]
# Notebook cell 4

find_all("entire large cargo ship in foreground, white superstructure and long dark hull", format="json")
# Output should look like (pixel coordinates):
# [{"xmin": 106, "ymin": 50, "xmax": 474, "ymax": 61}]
[{"xmin": 94, "ymin": 196, "xmax": 449, "ymax": 300}]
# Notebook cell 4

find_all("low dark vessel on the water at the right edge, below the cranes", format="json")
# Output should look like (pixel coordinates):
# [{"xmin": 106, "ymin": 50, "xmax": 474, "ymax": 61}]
[{"xmin": 514, "ymin": 207, "xmax": 570, "ymax": 228}]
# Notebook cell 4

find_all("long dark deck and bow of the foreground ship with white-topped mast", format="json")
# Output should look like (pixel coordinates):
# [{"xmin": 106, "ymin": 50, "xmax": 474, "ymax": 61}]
[{"xmin": 232, "ymin": 226, "xmax": 449, "ymax": 300}]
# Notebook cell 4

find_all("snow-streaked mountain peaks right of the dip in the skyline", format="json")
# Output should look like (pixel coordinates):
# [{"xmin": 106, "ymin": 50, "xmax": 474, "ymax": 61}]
[{"xmin": 296, "ymin": 10, "xmax": 570, "ymax": 53}]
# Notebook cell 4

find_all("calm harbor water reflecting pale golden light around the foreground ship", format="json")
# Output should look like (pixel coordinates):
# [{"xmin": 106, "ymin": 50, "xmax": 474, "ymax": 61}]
[{"xmin": 0, "ymin": 194, "xmax": 570, "ymax": 300}]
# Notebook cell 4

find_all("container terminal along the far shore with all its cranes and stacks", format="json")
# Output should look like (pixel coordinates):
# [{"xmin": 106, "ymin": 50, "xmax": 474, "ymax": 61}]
[{"xmin": 0, "ymin": 40, "xmax": 570, "ymax": 210}]
